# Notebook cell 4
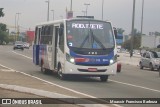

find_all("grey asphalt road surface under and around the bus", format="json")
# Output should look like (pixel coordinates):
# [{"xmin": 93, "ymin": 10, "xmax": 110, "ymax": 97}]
[{"xmin": 0, "ymin": 46, "xmax": 160, "ymax": 107}]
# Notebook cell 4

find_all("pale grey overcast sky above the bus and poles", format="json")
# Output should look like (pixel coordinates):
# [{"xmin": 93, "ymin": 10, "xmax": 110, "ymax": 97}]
[{"xmin": 0, "ymin": 0, "xmax": 160, "ymax": 34}]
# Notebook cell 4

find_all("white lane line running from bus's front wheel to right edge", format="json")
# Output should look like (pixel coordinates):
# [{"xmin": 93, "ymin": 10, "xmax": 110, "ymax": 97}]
[{"xmin": 109, "ymin": 79, "xmax": 160, "ymax": 93}]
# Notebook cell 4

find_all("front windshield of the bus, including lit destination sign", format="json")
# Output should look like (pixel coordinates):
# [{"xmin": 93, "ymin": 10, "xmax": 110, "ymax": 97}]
[{"xmin": 67, "ymin": 20, "xmax": 115, "ymax": 50}]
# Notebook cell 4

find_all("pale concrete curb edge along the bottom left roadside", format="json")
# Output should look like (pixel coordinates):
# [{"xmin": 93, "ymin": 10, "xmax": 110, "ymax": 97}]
[{"xmin": 0, "ymin": 84, "xmax": 109, "ymax": 107}]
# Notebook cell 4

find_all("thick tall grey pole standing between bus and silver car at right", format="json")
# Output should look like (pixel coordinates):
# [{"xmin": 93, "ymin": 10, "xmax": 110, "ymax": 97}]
[{"xmin": 130, "ymin": 0, "xmax": 136, "ymax": 57}]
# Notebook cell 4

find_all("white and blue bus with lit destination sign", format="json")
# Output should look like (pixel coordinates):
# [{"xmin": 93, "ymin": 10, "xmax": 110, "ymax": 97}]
[{"xmin": 33, "ymin": 18, "xmax": 117, "ymax": 81}]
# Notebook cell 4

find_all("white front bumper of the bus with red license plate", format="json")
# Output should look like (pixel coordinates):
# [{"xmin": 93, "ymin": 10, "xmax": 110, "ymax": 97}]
[{"xmin": 63, "ymin": 62, "xmax": 117, "ymax": 76}]
